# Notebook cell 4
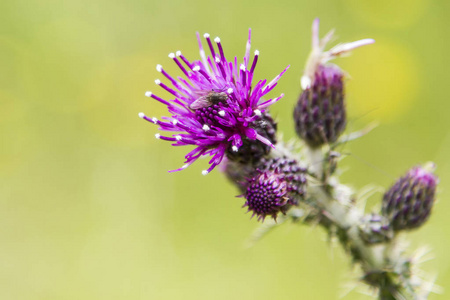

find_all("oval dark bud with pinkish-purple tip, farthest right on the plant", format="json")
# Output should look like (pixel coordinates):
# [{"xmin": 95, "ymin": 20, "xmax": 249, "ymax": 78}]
[{"xmin": 381, "ymin": 165, "xmax": 438, "ymax": 231}]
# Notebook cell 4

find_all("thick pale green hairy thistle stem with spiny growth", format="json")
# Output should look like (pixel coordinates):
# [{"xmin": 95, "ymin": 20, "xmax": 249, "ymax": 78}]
[{"xmin": 274, "ymin": 145, "xmax": 429, "ymax": 300}]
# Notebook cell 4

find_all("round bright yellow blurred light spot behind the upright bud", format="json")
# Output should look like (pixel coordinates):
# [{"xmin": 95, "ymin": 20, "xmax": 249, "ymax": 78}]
[{"xmin": 339, "ymin": 41, "xmax": 419, "ymax": 122}]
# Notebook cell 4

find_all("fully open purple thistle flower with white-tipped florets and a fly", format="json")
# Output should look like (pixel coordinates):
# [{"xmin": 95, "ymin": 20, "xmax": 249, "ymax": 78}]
[{"xmin": 139, "ymin": 30, "xmax": 289, "ymax": 175}]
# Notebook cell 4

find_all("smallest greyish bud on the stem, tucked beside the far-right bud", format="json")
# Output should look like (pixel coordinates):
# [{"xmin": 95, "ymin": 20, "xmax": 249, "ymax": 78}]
[{"xmin": 359, "ymin": 214, "xmax": 393, "ymax": 244}]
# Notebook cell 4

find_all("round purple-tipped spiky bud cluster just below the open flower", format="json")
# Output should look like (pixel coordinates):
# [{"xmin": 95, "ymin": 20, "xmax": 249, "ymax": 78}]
[{"xmin": 243, "ymin": 158, "xmax": 306, "ymax": 221}]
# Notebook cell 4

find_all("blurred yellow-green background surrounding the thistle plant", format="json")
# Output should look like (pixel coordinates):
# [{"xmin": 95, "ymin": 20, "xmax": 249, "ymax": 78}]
[{"xmin": 0, "ymin": 0, "xmax": 450, "ymax": 300}]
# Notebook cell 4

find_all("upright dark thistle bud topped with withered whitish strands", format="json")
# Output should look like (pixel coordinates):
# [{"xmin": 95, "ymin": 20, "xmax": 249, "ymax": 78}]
[{"xmin": 294, "ymin": 19, "xmax": 374, "ymax": 148}]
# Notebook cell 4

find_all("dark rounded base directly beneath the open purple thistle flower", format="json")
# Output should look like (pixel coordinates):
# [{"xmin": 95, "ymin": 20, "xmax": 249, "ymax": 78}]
[{"xmin": 226, "ymin": 112, "xmax": 277, "ymax": 165}]
